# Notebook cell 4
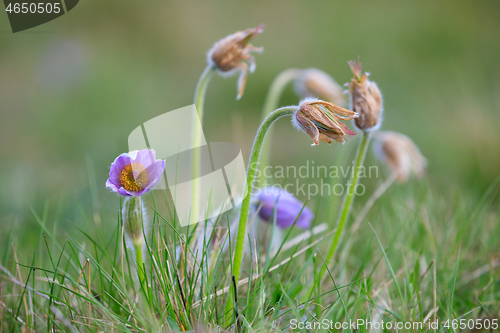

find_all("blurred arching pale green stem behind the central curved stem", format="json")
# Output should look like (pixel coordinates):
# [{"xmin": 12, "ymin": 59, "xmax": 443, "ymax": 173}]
[{"xmin": 258, "ymin": 68, "xmax": 301, "ymax": 186}]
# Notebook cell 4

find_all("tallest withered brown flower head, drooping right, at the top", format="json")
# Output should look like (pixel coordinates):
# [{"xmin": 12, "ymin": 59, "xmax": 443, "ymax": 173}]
[{"xmin": 207, "ymin": 24, "xmax": 264, "ymax": 99}]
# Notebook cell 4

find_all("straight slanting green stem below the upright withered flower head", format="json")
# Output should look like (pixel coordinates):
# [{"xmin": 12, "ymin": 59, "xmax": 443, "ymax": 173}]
[{"xmin": 320, "ymin": 132, "xmax": 371, "ymax": 278}]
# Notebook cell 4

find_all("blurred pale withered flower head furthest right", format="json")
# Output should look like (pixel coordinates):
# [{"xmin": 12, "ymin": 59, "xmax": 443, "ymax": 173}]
[{"xmin": 373, "ymin": 131, "xmax": 427, "ymax": 183}]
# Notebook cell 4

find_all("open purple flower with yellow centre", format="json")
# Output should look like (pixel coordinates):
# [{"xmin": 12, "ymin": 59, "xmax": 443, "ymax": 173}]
[{"xmin": 106, "ymin": 149, "xmax": 165, "ymax": 196}]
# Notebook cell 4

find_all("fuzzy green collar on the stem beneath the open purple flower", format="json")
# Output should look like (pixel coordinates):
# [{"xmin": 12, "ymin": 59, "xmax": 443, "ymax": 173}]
[{"xmin": 122, "ymin": 196, "xmax": 146, "ymax": 247}]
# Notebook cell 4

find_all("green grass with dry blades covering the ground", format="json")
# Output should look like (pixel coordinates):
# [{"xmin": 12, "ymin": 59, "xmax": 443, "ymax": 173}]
[{"xmin": 0, "ymin": 152, "xmax": 500, "ymax": 332}]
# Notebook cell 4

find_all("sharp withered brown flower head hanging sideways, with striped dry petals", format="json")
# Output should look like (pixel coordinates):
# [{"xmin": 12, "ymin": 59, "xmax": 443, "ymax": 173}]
[{"xmin": 292, "ymin": 98, "xmax": 358, "ymax": 145}]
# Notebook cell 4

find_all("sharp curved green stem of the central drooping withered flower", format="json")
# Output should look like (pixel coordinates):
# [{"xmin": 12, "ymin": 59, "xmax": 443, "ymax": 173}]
[{"xmin": 233, "ymin": 106, "xmax": 297, "ymax": 282}]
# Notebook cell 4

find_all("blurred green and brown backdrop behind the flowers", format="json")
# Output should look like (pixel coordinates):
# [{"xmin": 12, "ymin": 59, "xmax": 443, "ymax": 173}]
[{"xmin": 0, "ymin": 0, "xmax": 500, "ymax": 239}]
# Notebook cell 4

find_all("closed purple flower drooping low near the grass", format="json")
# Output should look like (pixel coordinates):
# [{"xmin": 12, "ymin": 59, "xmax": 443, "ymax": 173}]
[{"xmin": 258, "ymin": 187, "xmax": 314, "ymax": 229}]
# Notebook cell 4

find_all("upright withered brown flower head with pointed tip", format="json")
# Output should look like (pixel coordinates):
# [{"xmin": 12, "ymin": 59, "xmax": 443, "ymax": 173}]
[{"xmin": 347, "ymin": 59, "xmax": 382, "ymax": 131}]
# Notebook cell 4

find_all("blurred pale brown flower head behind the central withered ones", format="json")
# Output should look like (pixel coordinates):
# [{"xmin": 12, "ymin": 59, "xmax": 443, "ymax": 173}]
[{"xmin": 295, "ymin": 68, "xmax": 346, "ymax": 107}]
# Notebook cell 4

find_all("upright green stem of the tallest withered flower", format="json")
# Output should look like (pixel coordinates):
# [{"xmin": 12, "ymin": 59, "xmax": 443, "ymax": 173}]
[{"xmin": 190, "ymin": 65, "xmax": 216, "ymax": 222}]
